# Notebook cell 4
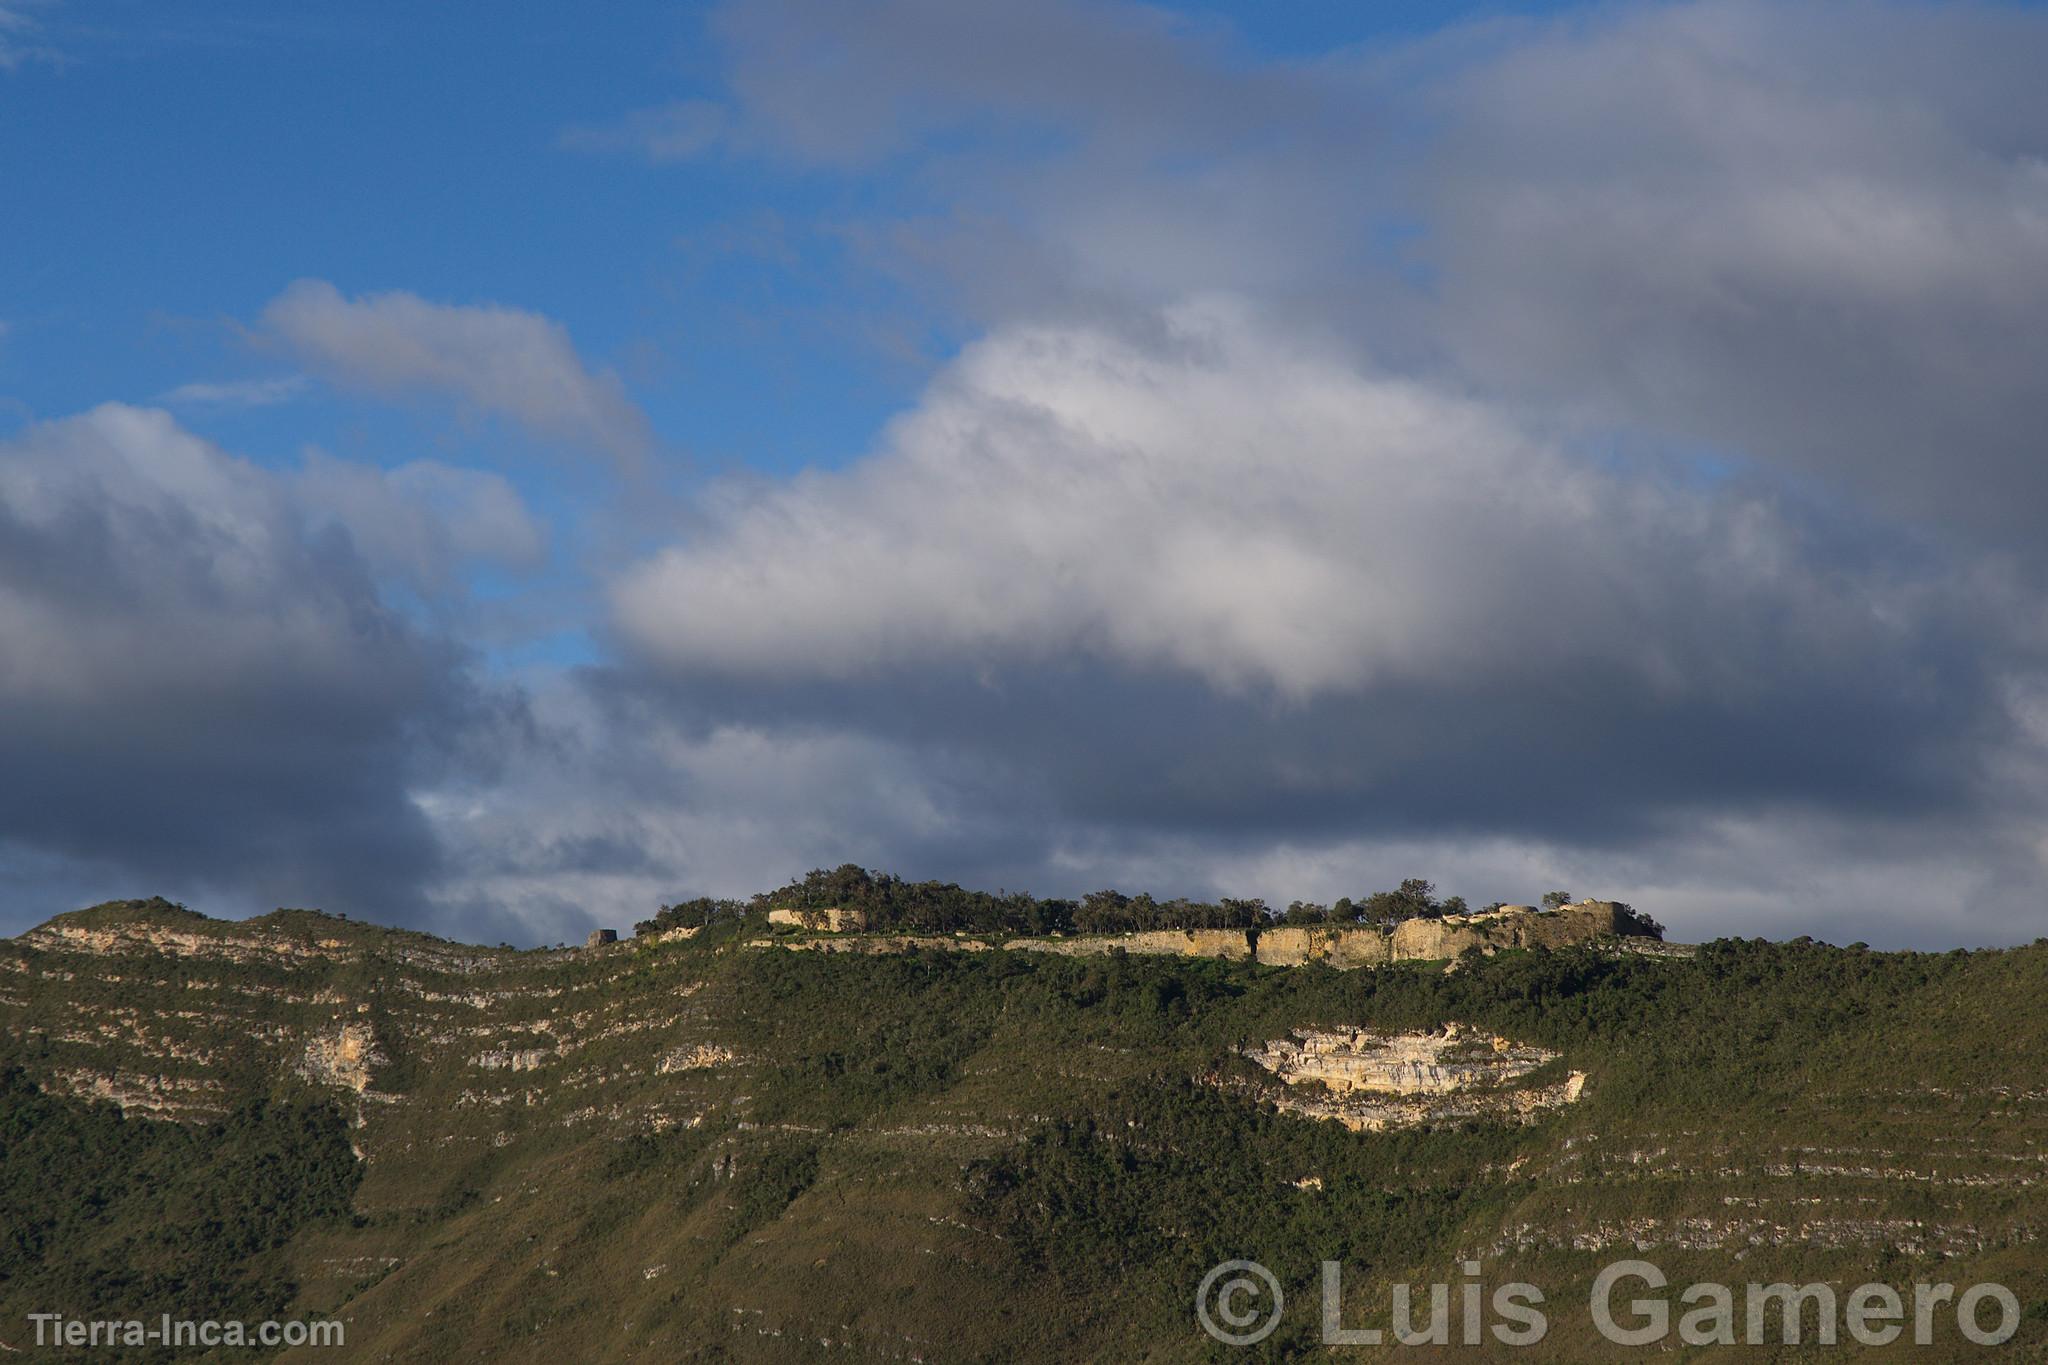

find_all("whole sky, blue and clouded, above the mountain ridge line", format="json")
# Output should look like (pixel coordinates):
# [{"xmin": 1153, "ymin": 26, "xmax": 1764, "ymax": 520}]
[{"xmin": 0, "ymin": 0, "xmax": 2048, "ymax": 948}]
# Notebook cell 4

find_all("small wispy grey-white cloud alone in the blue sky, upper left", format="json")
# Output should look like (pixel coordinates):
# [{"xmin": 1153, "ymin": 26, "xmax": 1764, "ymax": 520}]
[{"xmin": 262, "ymin": 280, "xmax": 649, "ymax": 465}]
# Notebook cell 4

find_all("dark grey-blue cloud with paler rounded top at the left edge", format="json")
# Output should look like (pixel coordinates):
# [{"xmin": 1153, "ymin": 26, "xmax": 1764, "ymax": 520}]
[{"xmin": 0, "ymin": 405, "xmax": 520, "ymax": 927}]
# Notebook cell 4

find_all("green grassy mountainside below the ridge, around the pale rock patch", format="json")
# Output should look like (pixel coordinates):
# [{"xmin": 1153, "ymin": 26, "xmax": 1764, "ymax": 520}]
[{"xmin": 0, "ymin": 907, "xmax": 2048, "ymax": 1361}]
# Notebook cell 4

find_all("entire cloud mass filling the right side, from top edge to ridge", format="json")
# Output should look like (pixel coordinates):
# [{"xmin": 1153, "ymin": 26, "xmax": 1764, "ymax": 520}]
[{"xmin": 569, "ymin": 0, "xmax": 2048, "ymax": 941}]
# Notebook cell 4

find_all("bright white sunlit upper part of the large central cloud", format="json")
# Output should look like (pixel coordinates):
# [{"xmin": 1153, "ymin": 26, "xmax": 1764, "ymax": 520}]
[{"xmin": 614, "ymin": 303, "xmax": 1966, "ymax": 698}]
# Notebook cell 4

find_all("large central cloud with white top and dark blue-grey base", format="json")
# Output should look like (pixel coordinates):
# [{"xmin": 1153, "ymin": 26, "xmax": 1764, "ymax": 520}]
[{"xmin": 598, "ymin": 298, "xmax": 2042, "ymax": 933}]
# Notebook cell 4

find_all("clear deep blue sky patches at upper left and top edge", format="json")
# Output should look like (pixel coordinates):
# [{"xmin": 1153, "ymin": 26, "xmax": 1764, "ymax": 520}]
[{"xmin": 0, "ymin": 0, "xmax": 1546, "ymax": 471}]
